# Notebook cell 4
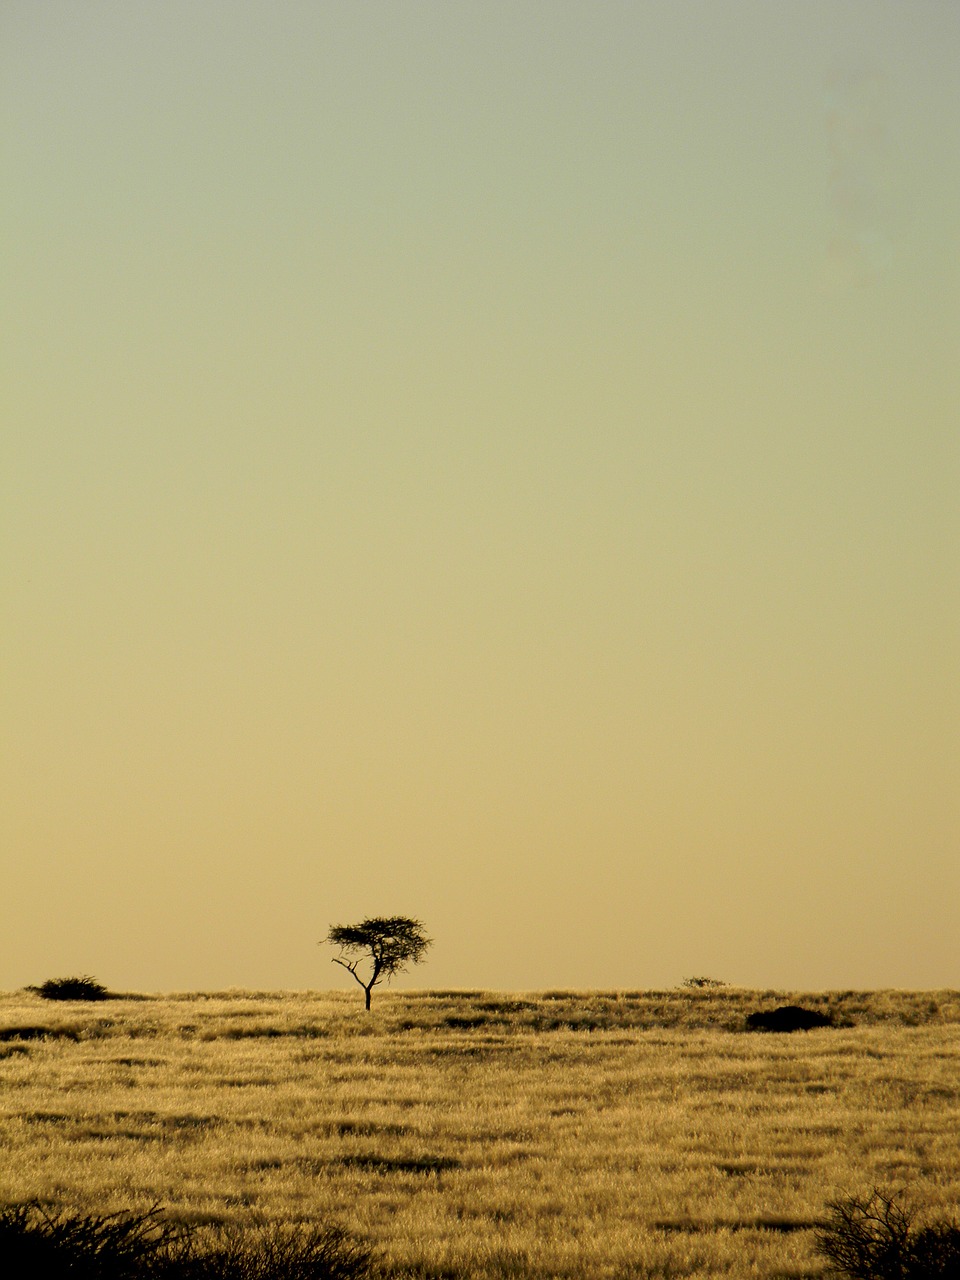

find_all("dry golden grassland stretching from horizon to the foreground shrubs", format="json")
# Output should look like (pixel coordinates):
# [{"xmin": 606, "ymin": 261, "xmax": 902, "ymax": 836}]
[{"xmin": 0, "ymin": 988, "xmax": 960, "ymax": 1280}]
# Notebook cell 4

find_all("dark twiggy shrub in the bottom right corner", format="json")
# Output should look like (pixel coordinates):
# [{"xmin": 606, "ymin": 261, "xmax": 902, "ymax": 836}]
[{"xmin": 817, "ymin": 1190, "xmax": 960, "ymax": 1280}]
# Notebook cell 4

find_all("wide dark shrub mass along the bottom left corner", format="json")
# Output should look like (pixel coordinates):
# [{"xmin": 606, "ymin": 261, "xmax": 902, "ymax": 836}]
[{"xmin": 0, "ymin": 1203, "xmax": 379, "ymax": 1280}]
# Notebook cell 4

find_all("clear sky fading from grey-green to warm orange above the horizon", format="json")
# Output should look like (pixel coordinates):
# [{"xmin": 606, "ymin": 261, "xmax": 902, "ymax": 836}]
[{"xmin": 0, "ymin": 0, "xmax": 960, "ymax": 991}]
